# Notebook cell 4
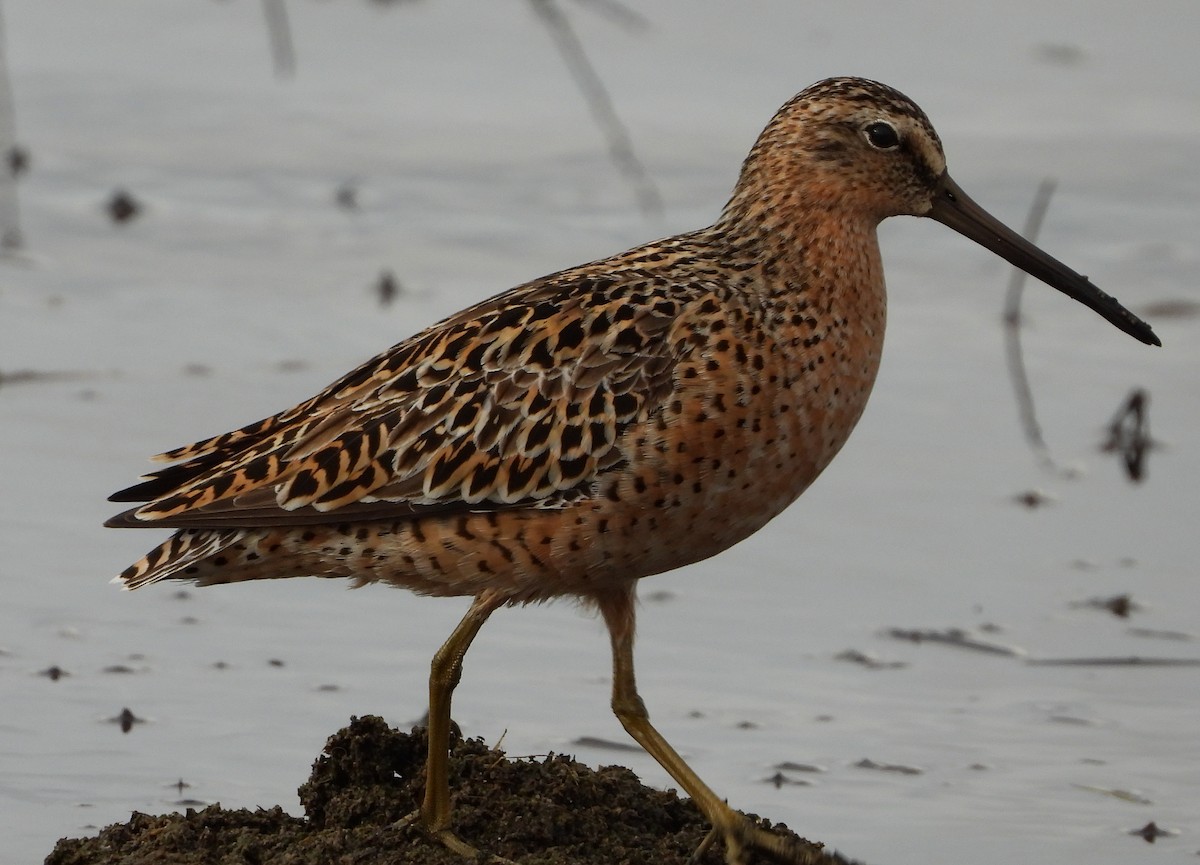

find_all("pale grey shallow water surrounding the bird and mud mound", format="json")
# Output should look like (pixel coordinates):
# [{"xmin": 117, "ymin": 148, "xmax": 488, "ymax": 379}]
[{"xmin": 7, "ymin": 0, "xmax": 1200, "ymax": 865}]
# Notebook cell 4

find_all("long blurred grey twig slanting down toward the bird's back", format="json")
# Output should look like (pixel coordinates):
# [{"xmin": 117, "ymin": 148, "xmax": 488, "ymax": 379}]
[{"xmin": 529, "ymin": 0, "xmax": 662, "ymax": 218}]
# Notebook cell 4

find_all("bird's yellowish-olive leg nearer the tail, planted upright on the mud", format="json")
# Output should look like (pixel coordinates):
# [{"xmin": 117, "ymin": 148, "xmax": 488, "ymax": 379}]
[{"xmin": 400, "ymin": 591, "xmax": 508, "ymax": 863}]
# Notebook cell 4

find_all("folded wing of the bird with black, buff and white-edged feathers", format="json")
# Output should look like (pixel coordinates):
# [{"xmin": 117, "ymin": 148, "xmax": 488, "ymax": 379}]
[{"xmin": 110, "ymin": 268, "xmax": 696, "ymax": 525}]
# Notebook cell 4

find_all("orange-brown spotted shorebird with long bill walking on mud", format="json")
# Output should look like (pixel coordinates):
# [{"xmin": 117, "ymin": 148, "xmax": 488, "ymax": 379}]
[{"xmin": 107, "ymin": 78, "xmax": 1160, "ymax": 864}]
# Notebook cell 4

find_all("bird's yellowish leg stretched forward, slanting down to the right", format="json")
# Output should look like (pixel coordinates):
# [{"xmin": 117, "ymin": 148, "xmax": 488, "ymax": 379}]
[{"xmin": 598, "ymin": 589, "xmax": 818, "ymax": 865}]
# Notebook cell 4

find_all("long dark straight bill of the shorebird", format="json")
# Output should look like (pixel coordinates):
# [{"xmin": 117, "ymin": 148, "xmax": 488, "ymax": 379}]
[{"xmin": 926, "ymin": 174, "xmax": 1163, "ymax": 346}]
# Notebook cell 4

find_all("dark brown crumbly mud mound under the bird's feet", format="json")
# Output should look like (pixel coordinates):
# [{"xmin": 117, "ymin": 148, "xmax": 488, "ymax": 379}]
[{"xmin": 46, "ymin": 716, "xmax": 846, "ymax": 865}]
